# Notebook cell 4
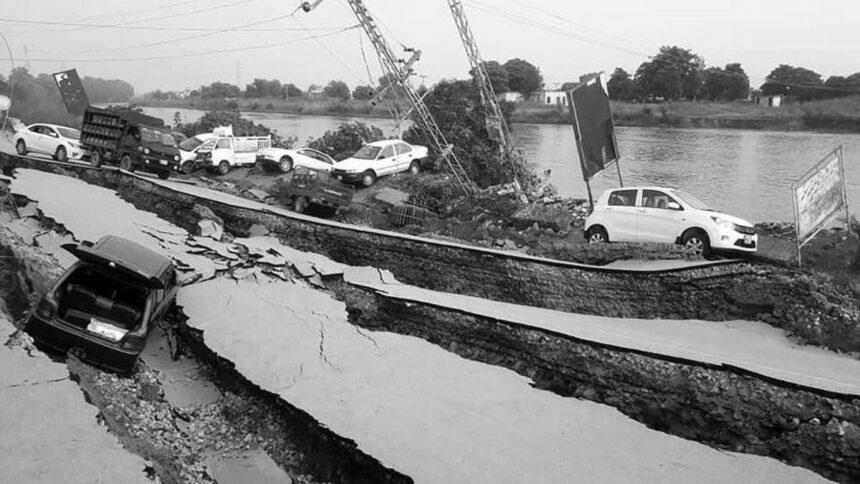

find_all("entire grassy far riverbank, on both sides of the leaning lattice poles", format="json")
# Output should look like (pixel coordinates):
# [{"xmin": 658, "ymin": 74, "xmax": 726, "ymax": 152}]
[{"xmin": 132, "ymin": 96, "xmax": 860, "ymax": 133}]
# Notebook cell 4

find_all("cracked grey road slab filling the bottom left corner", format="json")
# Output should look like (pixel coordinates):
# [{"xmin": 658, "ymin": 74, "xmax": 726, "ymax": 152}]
[{"xmin": 0, "ymin": 321, "xmax": 153, "ymax": 484}]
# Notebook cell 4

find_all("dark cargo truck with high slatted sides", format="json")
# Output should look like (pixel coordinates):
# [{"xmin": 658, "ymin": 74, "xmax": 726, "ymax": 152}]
[{"xmin": 81, "ymin": 106, "xmax": 181, "ymax": 179}]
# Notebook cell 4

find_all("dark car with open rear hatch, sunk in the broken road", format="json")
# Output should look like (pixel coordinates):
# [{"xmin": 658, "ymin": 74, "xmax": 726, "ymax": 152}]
[{"xmin": 24, "ymin": 236, "xmax": 177, "ymax": 373}]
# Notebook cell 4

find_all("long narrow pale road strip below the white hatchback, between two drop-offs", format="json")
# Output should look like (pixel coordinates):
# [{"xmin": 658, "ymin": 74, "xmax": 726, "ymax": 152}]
[{"xmin": 344, "ymin": 267, "xmax": 860, "ymax": 396}]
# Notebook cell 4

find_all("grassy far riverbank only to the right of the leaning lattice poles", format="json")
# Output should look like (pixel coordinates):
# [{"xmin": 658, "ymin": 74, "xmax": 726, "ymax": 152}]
[{"xmin": 512, "ymin": 96, "xmax": 860, "ymax": 132}]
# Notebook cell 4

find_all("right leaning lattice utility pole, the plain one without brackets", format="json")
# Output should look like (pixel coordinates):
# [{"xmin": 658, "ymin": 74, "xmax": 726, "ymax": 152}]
[{"xmin": 448, "ymin": 0, "xmax": 522, "ymax": 191}]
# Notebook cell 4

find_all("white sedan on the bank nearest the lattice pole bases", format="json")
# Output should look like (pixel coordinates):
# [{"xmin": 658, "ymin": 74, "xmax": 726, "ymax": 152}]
[{"xmin": 331, "ymin": 139, "xmax": 427, "ymax": 187}]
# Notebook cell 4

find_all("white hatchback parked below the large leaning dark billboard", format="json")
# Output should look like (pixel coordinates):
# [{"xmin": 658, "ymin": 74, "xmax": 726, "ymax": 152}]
[{"xmin": 585, "ymin": 187, "xmax": 758, "ymax": 255}]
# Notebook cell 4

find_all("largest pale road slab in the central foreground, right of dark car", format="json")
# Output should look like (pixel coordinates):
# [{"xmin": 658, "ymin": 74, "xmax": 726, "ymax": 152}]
[{"xmin": 178, "ymin": 278, "xmax": 823, "ymax": 483}]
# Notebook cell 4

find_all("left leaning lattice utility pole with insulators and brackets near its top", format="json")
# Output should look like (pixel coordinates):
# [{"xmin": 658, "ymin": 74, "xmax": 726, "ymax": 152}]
[{"xmin": 302, "ymin": 0, "xmax": 476, "ymax": 195}]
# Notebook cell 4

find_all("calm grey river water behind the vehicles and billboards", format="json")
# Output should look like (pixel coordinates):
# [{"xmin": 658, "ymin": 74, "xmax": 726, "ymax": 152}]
[{"xmin": 144, "ymin": 108, "xmax": 860, "ymax": 222}]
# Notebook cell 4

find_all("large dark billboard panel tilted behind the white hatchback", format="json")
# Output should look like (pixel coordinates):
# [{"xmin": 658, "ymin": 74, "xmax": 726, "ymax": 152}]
[{"xmin": 567, "ymin": 74, "xmax": 619, "ymax": 181}]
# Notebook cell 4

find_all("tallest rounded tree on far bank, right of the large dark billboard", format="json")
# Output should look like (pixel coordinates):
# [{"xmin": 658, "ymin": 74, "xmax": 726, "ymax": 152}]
[{"xmin": 633, "ymin": 45, "xmax": 705, "ymax": 101}]
